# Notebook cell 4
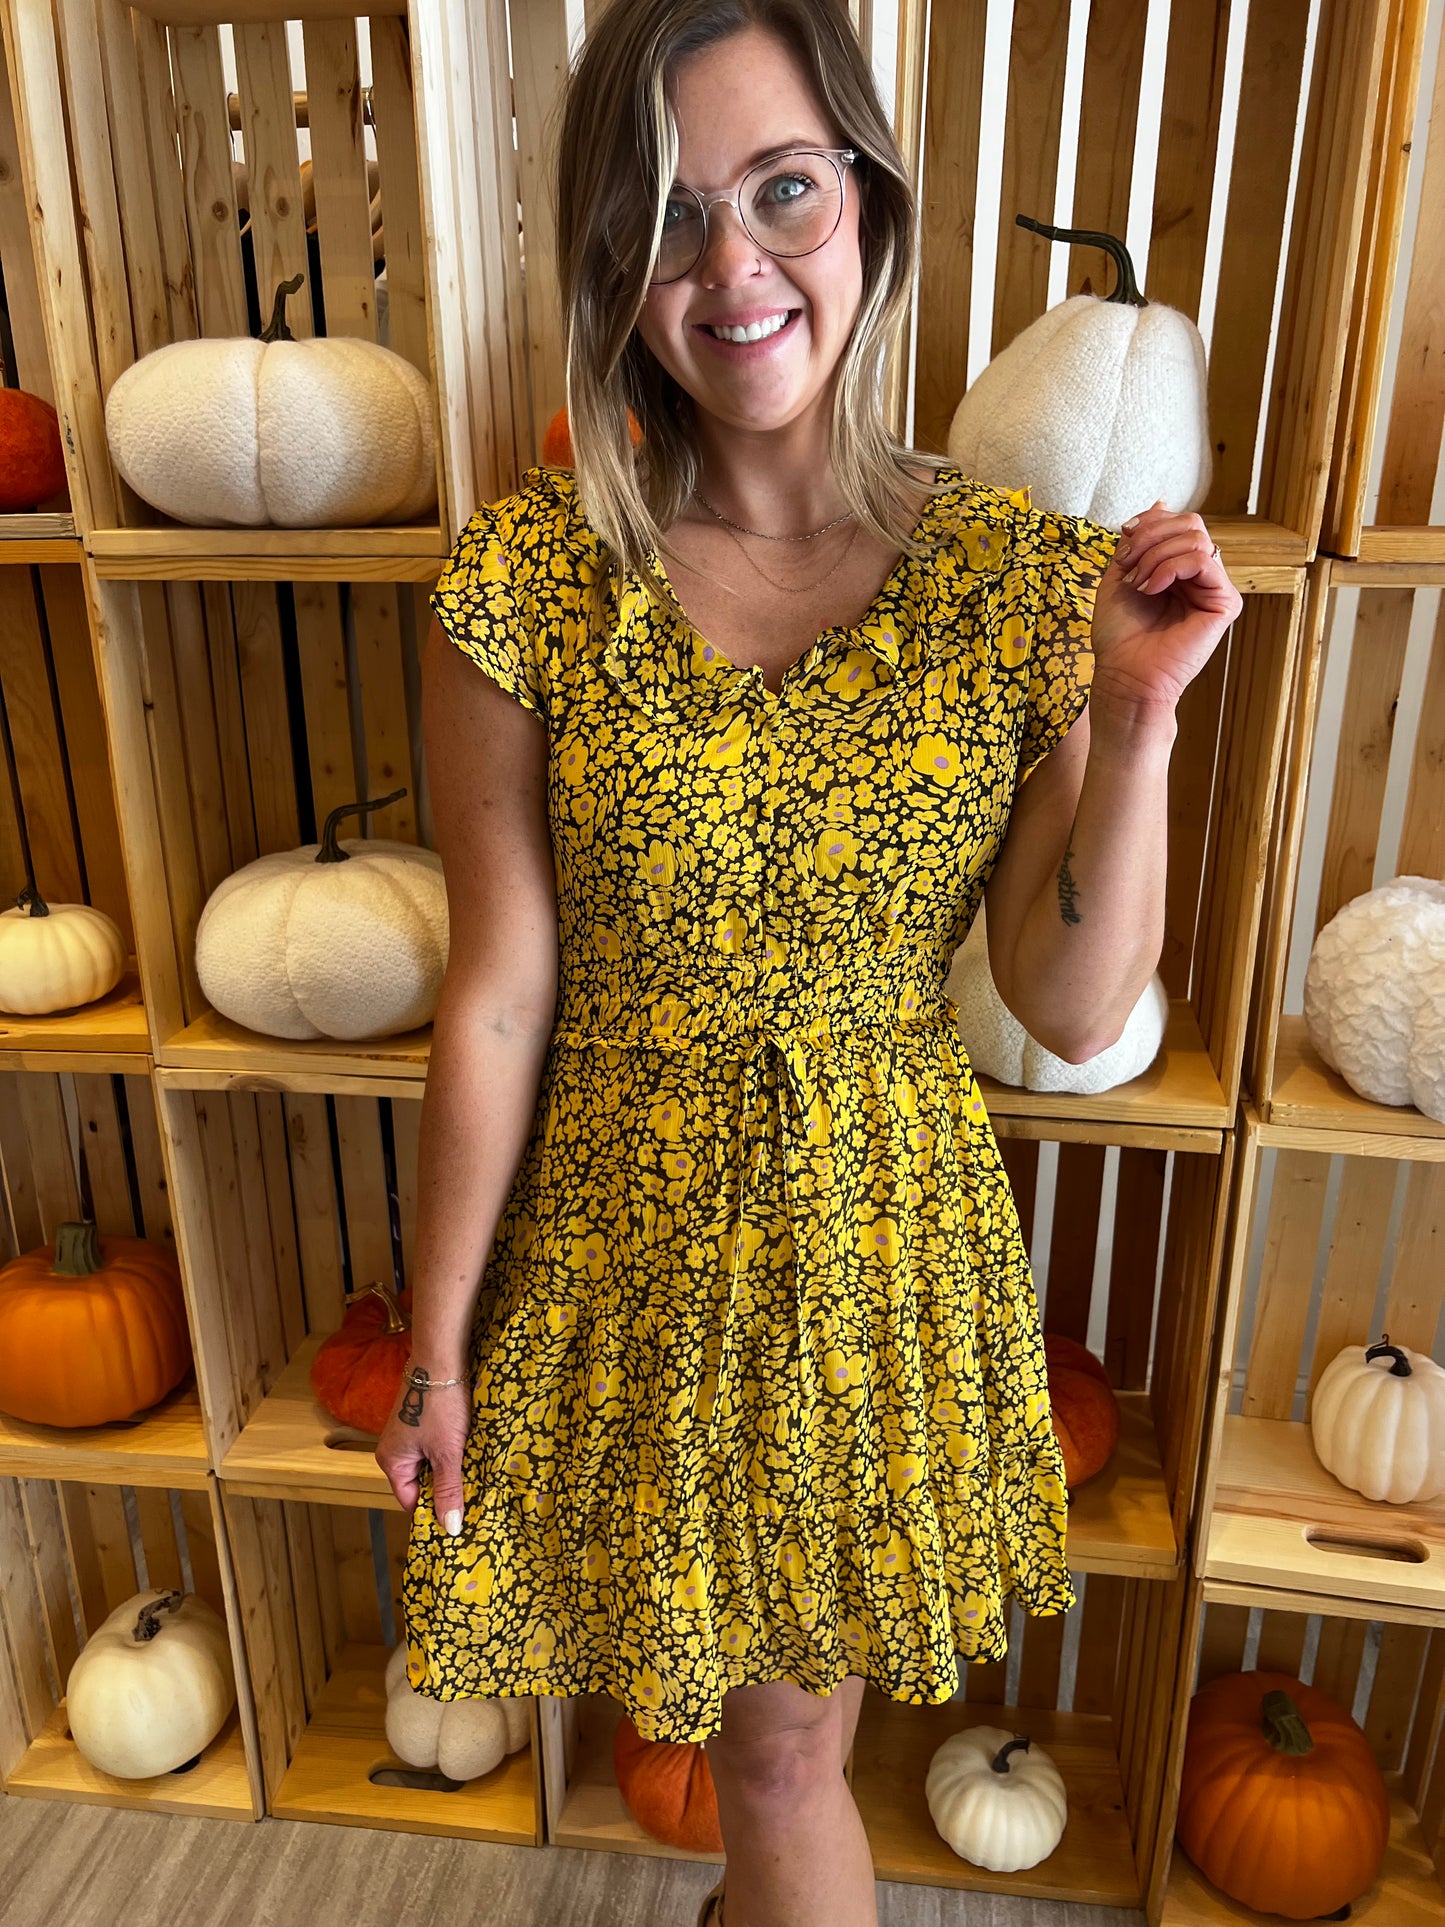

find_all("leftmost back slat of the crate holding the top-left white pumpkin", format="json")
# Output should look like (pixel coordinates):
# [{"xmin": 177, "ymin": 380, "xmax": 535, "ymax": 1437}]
[{"xmin": 170, "ymin": 27, "xmax": 250, "ymax": 335}]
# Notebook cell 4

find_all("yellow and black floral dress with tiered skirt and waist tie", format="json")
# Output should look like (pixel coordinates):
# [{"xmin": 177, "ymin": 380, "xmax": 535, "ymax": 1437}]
[{"xmin": 403, "ymin": 466, "xmax": 1117, "ymax": 1740}]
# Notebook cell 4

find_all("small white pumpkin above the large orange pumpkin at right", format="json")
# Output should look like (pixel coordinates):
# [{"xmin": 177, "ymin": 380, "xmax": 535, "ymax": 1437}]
[{"xmin": 1310, "ymin": 1333, "xmax": 1445, "ymax": 1505}]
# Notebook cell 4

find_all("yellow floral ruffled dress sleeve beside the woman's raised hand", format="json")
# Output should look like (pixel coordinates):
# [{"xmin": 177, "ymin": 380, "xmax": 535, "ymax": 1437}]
[{"xmin": 1010, "ymin": 488, "xmax": 1119, "ymax": 782}]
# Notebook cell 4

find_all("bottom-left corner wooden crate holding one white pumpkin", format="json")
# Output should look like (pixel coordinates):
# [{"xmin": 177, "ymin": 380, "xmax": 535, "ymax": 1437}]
[{"xmin": 0, "ymin": 1451, "xmax": 264, "ymax": 1819}]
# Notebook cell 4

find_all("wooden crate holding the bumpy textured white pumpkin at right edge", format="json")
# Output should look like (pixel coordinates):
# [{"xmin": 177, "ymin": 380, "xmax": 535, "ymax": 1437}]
[{"xmin": 1247, "ymin": 557, "xmax": 1445, "ymax": 1141}]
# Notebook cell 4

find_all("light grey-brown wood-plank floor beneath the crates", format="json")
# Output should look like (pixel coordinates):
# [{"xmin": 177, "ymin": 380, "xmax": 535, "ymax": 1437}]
[{"xmin": 0, "ymin": 1796, "xmax": 1143, "ymax": 1927}]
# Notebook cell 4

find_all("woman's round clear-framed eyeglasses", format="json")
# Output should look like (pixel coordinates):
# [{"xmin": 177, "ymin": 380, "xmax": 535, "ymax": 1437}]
[{"xmin": 651, "ymin": 146, "xmax": 857, "ymax": 287}]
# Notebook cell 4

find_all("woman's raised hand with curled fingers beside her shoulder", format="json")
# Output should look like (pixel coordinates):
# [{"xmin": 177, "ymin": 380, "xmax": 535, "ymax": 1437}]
[{"xmin": 1089, "ymin": 503, "xmax": 1245, "ymax": 709}]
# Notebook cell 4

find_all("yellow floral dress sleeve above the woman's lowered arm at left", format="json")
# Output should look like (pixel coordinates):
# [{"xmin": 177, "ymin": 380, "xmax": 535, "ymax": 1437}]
[{"xmin": 432, "ymin": 499, "xmax": 551, "ymax": 723}]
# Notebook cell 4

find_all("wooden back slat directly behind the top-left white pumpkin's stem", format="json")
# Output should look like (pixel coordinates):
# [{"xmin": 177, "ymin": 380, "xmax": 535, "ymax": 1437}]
[{"xmin": 235, "ymin": 19, "xmax": 316, "ymax": 341}]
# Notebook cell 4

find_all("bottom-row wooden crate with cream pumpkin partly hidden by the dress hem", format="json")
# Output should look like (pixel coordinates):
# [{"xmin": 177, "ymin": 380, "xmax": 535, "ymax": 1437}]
[{"xmin": 222, "ymin": 1487, "xmax": 541, "ymax": 1846}]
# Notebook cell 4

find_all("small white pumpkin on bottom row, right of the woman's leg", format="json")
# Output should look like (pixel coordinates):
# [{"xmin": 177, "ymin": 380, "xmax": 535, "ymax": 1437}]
[{"xmin": 923, "ymin": 1727, "xmax": 1069, "ymax": 1873}]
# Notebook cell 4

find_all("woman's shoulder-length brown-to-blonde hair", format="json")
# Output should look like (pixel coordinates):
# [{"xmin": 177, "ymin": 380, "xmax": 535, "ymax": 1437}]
[{"xmin": 553, "ymin": 0, "xmax": 956, "ymax": 616}]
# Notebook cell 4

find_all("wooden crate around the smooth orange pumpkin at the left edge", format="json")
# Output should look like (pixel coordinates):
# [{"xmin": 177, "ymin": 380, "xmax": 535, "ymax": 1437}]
[{"xmin": 0, "ymin": 1058, "xmax": 210, "ymax": 1479}]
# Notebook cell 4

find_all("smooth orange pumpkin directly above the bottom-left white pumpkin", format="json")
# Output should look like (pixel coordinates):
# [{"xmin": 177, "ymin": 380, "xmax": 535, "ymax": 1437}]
[{"xmin": 0, "ymin": 1224, "xmax": 191, "ymax": 1426}]
